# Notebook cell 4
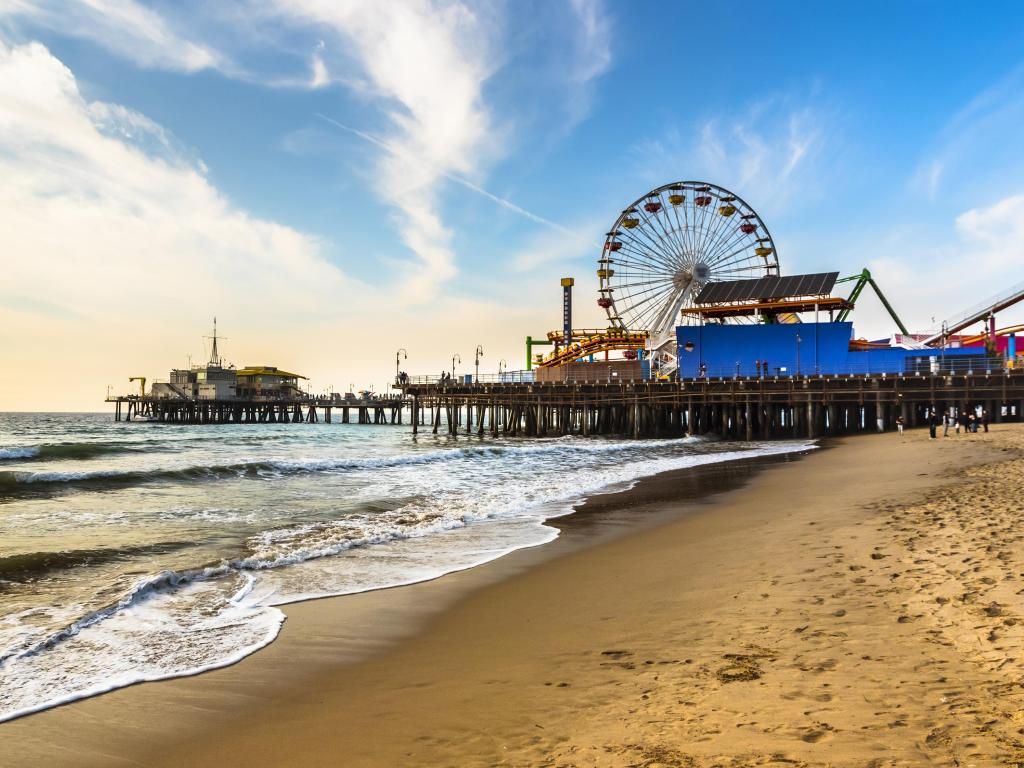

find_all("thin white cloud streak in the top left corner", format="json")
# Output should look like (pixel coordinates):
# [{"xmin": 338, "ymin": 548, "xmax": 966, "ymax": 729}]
[{"xmin": 0, "ymin": 0, "xmax": 223, "ymax": 72}]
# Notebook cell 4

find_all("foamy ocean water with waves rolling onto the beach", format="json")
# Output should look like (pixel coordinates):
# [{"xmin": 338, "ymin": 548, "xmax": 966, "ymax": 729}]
[{"xmin": 0, "ymin": 414, "xmax": 811, "ymax": 722}]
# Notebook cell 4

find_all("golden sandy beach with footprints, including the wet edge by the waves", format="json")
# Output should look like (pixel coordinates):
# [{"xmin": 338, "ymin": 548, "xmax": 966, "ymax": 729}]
[{"xmin": 0, "ymin": 425, "xmax": 1024, "ymax": 768}]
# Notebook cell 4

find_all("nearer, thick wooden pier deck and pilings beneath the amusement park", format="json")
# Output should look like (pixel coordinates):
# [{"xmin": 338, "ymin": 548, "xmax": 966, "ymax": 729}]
[{"xmin": 400, "ymin": 370, "xmax": 1024, "ymax": 440}]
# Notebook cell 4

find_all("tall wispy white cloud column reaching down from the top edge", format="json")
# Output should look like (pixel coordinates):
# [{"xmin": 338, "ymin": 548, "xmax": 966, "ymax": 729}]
[{"xmin": 264, "ymin": 0, "xmax": 495, "ymax": 301}]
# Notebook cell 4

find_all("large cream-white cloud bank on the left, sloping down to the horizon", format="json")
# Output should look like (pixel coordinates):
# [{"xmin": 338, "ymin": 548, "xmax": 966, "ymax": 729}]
[{"xmin": 0, "ymin": 37, "xmax": 585, "ymax": 410}]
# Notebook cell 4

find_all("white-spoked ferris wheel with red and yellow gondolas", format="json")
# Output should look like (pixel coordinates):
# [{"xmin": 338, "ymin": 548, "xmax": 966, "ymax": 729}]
[{"xmin": 597, "ymin": 181, "xmax": 779, "ymax": 342}]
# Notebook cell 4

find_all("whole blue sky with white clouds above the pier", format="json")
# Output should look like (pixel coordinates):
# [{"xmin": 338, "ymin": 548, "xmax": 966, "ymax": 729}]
[{"xmin": 0, "ymin": 0, "xmax": 1024, "ymax": 411}]
